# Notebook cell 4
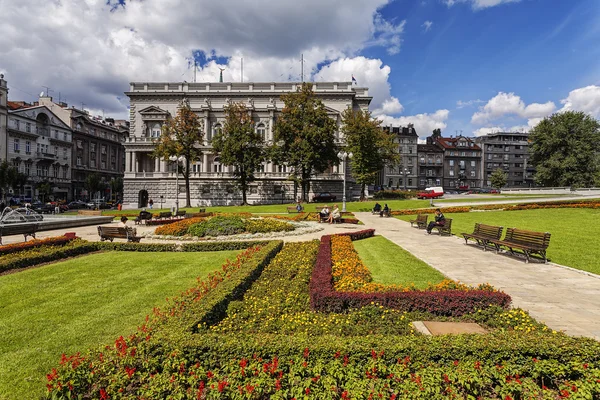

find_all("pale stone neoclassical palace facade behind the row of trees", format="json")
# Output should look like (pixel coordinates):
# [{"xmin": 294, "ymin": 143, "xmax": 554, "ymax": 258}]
[{"xmin": 123, "ymin": 82, "xmax": 371, "ymax": 208}]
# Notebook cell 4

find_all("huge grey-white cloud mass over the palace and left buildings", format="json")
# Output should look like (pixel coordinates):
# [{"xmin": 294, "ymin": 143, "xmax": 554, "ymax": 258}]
[{"xmin": 0, "ymin": 0, "xmax": 406, "ymax": 117}]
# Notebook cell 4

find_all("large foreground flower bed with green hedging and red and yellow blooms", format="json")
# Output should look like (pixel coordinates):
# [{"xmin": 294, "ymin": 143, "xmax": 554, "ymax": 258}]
[{"xmin": 47, "ymin": 242, "xmax": 600, "ymax": 399}]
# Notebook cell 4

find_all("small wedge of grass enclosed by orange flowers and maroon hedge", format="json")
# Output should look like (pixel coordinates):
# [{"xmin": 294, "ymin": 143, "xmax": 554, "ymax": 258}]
[{"xmin": 352, "ymin": 236, "xmax": 445, "ymax": 289}]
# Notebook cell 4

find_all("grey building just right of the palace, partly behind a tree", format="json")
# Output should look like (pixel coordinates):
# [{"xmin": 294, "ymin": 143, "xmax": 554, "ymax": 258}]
[{"xmin": 380, "ymin": 124, "xmax": 419, "ymax": 190}]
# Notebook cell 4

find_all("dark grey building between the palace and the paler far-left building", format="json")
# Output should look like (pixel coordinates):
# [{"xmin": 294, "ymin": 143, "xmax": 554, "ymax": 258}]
[{"xmin": 39, "ymin": 96, "xmax": 129, "ymax": 200}]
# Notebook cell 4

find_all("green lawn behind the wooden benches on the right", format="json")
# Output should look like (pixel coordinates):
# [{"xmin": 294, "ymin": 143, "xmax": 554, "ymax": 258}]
[{"xmin": 399, "ymin": 208, "xmax": 600, "ymax": 274}]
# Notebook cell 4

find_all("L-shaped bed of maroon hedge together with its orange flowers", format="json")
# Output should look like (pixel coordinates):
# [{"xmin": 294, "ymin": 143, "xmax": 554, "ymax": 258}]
[{"xmin": 310, "ymin": 236, "xmax": 511, "ymax": 316}]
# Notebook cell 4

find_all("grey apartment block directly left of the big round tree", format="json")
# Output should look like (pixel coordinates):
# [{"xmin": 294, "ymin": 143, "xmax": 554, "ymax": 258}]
[{"xmin": 476, "ymin": 132, "xmax": 535, "ymax": 188}]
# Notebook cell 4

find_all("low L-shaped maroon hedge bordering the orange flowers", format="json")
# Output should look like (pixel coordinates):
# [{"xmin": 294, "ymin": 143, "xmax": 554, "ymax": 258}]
[{"xmin": 310, "ymin": 235, "xmax": 511, "ymax": 316}]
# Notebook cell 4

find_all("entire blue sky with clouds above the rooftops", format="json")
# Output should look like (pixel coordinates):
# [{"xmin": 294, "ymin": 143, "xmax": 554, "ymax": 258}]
[{"xmin": 0, "ymin": 0, "xmax": 600, "ymax": 138}]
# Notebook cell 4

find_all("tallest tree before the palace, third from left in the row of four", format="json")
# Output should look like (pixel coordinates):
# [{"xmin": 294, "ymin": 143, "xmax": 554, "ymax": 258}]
[{"xmin": 271, "ymin": 83, "xmax": 339, "ymax": 201}]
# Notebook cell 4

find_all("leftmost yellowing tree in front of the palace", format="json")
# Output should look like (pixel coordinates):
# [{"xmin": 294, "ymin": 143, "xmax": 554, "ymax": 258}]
[{"xmin": 153, "ymin": 99, "xmax": 204, "ymax": 207}]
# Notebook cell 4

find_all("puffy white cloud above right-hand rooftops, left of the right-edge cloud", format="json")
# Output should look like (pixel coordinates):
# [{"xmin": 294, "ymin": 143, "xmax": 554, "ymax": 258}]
[{"xmin": 471, "ymin": 92, "xmax": 556, "ymax": 125}]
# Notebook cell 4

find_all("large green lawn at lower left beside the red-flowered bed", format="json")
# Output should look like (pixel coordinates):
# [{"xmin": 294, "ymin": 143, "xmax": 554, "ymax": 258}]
[{"xmin": 0, "ymin": 251, "xmax": 239, "ymax": 399}]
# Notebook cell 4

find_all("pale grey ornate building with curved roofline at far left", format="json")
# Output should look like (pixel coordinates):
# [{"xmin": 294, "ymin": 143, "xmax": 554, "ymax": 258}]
[{"xmin": 7, "ymin": 101, "xmax": 72, "ymax": 200}]
